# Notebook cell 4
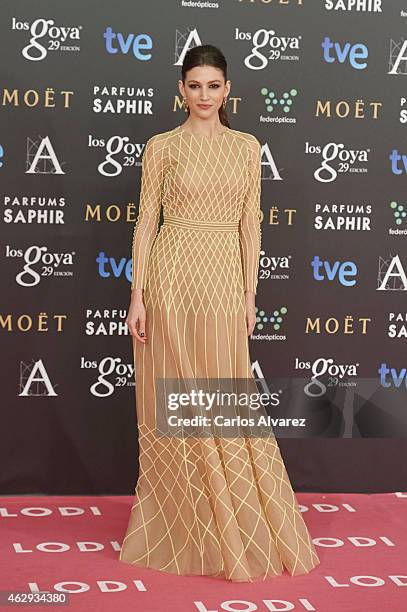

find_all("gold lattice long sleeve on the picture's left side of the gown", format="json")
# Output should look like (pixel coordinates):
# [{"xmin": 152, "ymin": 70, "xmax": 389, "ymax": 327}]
[{"xmin": 131, "ymin": 136, "xmax": 164, "ymax": 290}]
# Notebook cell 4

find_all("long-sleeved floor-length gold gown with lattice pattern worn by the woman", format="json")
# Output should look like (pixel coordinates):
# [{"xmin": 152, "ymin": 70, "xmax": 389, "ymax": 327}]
[{"xmin": 119, "ymin": 125, "xmax": 320, "ymax": 582}]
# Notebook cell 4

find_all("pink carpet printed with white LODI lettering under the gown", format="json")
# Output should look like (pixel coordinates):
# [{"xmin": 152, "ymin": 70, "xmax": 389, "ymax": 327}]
[{"xmin": 0, "ymin": 493, "xmax": 407, "ymax": 612}]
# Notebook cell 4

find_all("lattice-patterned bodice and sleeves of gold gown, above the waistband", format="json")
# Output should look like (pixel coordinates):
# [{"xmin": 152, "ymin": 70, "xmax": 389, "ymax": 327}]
[{"xmin": 131, "ymin": 126, "xmax": 261, "ymax": 293}]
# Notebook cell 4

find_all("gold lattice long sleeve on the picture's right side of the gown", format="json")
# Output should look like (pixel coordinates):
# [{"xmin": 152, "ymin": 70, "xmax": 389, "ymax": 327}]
[{"xmin": 239, "ymin": 137, "xmax": 261, "ymax": 293}]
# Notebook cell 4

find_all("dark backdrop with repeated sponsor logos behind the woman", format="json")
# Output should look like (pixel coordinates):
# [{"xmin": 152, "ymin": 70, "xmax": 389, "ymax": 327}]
[{"xmin": 0, "ymin": 0, "xmax": 407, "ymax": 494}]
